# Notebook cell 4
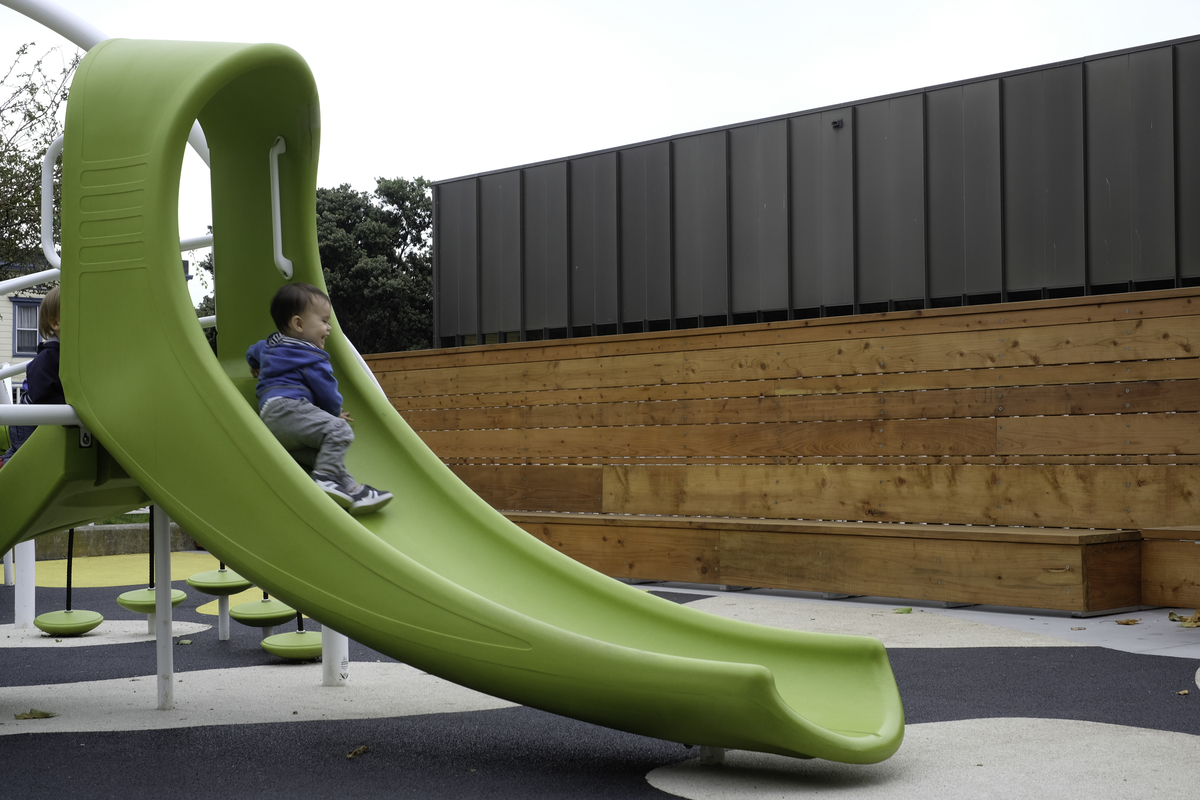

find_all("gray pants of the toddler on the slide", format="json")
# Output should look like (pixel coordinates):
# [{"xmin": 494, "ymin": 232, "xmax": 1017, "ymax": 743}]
[{"xmin": 259, "ymin": 397, "xmax": 358, "ymax": 488}]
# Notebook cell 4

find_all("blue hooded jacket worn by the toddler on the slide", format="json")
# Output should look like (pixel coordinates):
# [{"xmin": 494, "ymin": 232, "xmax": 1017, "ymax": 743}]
[{"xmin": 246, "ymin": 333, "xmax": 342, "ymax": 416}]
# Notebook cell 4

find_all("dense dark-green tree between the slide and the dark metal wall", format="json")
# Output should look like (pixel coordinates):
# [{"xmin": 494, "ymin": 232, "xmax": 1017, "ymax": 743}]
[{"xmin": 317, "ymin": 178, "xmax": 433, "ymax": 353}]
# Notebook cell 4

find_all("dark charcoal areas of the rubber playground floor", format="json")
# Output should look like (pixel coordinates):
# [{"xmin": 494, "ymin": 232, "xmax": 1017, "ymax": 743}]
[{"xmin": 0, "ymin": 582, "xmax": 1200, "ymax": 800}]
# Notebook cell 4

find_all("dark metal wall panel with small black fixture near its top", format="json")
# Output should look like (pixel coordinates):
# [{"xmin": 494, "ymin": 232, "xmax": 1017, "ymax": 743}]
[{"xmin": 791, "ymin": 108, "xmax": 854, "ymax": 308}]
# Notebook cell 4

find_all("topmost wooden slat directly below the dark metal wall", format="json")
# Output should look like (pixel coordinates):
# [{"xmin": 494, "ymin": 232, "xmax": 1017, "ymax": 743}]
[{"xmin": 364, "ymin": 288, "xmax": 1200, "ymax": 373}]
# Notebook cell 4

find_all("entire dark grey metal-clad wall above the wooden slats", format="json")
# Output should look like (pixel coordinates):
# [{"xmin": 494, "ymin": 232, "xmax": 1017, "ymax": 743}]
[{"xmin": 434, "ymin": 37, "xmax": 1200, "ymax": 345}]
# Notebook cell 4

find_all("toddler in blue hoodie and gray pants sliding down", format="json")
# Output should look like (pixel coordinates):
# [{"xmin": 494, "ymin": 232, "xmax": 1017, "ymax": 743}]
[{"xmin": 246, "ymin": 283, "xmax": 392, "ymax": 516}]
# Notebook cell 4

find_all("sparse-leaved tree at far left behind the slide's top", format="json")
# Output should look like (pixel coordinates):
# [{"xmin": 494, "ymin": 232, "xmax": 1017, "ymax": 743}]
[{"xmin": 0, "ymin": 44, "xmax": 79, "ymax": 277}]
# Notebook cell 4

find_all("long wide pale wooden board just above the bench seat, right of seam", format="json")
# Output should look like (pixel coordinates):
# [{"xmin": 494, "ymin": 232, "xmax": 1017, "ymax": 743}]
[{"xmin": 604, "ymin": 464, "xmax": 1200, "ymax": 528}]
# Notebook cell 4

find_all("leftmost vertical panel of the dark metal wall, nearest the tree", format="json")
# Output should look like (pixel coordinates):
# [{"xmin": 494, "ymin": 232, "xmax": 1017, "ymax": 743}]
[{"xmin": 438, "ymin": 180, "xmax": 479, "ymax": 336}]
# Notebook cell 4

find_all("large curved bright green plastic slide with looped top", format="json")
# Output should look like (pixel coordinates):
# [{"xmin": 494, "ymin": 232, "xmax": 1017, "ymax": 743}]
[{"xmin": 0, "ymin": 40, "xmax": 904, "ymax": 763}]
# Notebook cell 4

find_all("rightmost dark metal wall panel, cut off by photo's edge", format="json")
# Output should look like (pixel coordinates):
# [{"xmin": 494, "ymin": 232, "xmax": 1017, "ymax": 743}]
[{"xmin": 1175, "ymin": 42, "xmax": 1200, "ymax": 277}]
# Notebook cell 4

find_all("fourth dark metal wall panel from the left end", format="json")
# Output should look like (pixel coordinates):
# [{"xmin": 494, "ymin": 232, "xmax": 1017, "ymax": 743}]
[{"xmin": 571, "ymin": 152, "xmax": 617, "ymax": 325}]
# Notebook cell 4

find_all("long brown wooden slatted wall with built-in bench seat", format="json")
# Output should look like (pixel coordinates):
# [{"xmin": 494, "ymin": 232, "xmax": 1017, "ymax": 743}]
[{"xmin": 367, "ymin": 289, "xmax": 1200, "ymax": 613}]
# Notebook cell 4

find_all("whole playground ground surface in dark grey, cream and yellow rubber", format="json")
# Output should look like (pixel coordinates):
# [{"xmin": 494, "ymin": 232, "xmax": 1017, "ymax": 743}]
[{"xmin": 0, "ymin": 552, "xmax": 1200, "ymax": 799}]
